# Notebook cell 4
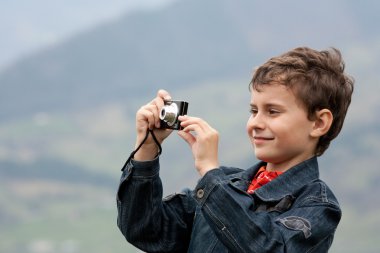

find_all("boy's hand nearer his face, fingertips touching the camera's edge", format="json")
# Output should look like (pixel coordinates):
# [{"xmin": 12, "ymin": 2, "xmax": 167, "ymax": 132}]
[{"xmin": 178, "ymin": 116, "xmax": 219, "ymax": 176}]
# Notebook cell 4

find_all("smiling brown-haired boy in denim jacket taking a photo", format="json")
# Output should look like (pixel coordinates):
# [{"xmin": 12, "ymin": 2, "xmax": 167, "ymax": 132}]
[{"xmin": 117, "ymin": 48, "xmax": 354, "ymax": 253}]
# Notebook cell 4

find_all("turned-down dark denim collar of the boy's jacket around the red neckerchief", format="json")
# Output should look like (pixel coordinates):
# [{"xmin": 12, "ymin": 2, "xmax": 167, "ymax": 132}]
[{"xmin": 243, "ymin": 157, "xmax": 319, "ymax": 201}]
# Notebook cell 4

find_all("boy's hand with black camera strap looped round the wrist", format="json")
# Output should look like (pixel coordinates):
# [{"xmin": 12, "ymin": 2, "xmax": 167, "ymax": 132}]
[{"xmin": 134, "ymin": 90, "xmax": 172, "ymax": 161}]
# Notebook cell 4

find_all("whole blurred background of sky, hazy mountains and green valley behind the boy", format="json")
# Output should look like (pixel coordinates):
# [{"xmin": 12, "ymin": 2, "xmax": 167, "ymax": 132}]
[{"xmin": 0, "ymin": 0, "xmax": 380, "ymax": 253}]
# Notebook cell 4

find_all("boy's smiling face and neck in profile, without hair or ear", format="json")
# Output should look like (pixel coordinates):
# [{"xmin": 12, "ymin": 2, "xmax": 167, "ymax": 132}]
[{"xmin": 247, "ymin": 84, "xmax": 318, "ymax": 171}]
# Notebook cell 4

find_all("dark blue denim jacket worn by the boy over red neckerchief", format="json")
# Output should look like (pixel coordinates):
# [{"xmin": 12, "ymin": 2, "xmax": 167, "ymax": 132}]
[{"xmin": 117, "ymin": 157, "xmax": 341, "ymax": 253}]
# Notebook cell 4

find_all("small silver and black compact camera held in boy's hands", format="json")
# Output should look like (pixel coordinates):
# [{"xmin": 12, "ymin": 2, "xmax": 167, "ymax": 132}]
[{"xmin": 160, "ymin": 101, "xmax": 189, "ymax": 130}]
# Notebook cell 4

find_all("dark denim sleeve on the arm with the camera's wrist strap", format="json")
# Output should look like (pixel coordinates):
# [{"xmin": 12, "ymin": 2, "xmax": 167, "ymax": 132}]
[{"xmin": 117, "ymin": 158, "xmax": 196, "ymax": 252}]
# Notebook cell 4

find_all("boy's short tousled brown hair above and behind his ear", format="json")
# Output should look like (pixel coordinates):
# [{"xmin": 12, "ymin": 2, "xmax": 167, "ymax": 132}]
[{"xmin": 250, "ymin": 47, "xmax": 354, "ymax": 156}]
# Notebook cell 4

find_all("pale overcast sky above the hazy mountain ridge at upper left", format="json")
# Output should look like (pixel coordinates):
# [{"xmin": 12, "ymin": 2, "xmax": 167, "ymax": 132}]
[{"xmin": 0, "ymin": 0, "xmax": 176, "ymax": 71}]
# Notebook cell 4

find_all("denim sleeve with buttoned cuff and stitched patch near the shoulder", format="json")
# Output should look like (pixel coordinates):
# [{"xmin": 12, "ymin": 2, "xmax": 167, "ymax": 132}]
[{"xmin": 195, "ymin": 169, "xmax": 341, "ymax": 253}]
